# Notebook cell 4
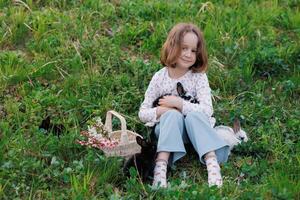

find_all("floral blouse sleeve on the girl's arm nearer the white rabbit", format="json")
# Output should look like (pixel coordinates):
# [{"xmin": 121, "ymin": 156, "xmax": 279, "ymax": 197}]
[{"xmin": 182, "ymin": 74, "xmax": 213, "ymax": 117}]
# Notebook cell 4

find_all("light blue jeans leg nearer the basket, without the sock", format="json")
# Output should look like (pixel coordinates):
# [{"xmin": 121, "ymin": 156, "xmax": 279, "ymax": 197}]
[{"xmin": 155, "ymin": 110, "xmax": 187, "ymax": 164}]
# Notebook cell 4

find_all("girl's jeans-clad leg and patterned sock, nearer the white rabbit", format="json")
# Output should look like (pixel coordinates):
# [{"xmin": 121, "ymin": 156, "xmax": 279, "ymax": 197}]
[{"xmin": 185, "ymin": 112, "xmax": 229, "ymax": 186}]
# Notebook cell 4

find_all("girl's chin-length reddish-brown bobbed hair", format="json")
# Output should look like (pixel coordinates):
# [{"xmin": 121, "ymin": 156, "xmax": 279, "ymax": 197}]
[{"xmin": 160, "ymin": 23, "xmax": 208, "ymax": 72}]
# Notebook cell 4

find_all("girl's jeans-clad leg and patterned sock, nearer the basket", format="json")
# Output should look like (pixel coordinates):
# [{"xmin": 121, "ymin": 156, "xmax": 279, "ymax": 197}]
[{"xmin": 153, "ymin": 110, "xmax": 186, "ymax": 187}]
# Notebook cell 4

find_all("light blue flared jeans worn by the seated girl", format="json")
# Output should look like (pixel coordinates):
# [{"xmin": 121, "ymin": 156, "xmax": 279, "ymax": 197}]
[{"xmin": 155, "ymin": 110, "xmax": 229, "ymax": 164}]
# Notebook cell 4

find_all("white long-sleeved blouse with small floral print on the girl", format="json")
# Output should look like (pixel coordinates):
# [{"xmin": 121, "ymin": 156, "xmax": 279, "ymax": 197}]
[{"xmin": 139, "ymin": 67, "xmax": 216, "ymax": 127}]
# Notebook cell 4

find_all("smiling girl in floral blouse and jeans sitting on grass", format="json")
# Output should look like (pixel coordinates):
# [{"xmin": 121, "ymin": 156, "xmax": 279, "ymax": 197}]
[{"xmin": 139, "ymin": 23, "xmax": 229, "ymax": 187}]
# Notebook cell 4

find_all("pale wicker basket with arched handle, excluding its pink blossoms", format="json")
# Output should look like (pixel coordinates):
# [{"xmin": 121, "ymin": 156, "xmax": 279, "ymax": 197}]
[{"xmin": 102, "ymin": 110, "xmax": 143, "ymax": 158}]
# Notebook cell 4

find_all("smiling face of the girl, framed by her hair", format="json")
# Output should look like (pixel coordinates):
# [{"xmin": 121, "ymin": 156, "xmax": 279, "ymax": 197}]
[{"xmin": 176, "ymin": 32, "xmax": 198, "ymax": 69}]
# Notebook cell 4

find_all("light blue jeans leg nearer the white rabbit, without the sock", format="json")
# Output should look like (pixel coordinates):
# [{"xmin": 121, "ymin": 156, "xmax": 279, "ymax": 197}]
[{"xmin": 185, "ymin": 112, "xmax": 229, "ymax": 164}]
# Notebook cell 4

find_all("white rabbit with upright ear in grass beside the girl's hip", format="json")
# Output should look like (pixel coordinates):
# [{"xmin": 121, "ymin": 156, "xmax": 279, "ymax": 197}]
[{"xmin": 214, "ymin": 119, "xmax": 248, "ymax": 154}]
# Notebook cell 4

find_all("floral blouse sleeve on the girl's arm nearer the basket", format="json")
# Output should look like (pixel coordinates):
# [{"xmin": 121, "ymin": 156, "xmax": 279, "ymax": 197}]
[{"xmin": 139, "ymin": 74, "xmax": 159, "ymax": 126}]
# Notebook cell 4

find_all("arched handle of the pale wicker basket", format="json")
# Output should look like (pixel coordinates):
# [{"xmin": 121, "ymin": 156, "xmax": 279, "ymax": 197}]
[{"xmin": 104, "ymin": 110, "xmax": 129, "ymax": 144}]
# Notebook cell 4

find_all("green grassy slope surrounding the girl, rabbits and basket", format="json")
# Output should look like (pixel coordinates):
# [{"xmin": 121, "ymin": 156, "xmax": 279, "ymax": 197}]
[{"xmin": 0, "ymin": 0, "xmax": 300, "ymax": 199}]
